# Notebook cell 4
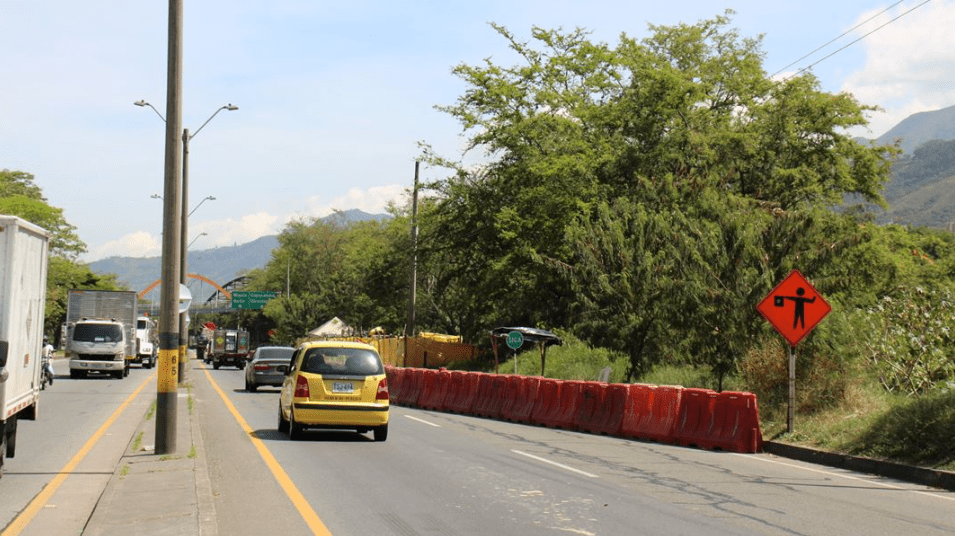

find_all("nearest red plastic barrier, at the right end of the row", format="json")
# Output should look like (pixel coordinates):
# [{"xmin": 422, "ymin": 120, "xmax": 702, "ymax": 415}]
[{"xmin": 704, "ymin": 391, "xmax": 763, "ymax": 454}]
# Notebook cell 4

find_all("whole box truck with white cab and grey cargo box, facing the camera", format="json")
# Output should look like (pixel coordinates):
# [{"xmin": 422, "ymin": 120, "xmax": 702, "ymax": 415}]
[{"xmin": 64, "ymin": 289, "xmax": 139, "ymax": 379}]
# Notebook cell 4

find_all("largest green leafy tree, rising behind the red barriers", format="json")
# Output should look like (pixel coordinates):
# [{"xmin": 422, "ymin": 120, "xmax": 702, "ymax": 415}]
[{"xmin": 430, "ymin": 16, "xmax": 895, "ymax": 378}]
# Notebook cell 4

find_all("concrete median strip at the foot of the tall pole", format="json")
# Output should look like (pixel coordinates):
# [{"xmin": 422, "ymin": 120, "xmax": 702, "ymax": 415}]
[{"xmin": 83, "ymin": 359, "xmax": 218, "ymax": 536}]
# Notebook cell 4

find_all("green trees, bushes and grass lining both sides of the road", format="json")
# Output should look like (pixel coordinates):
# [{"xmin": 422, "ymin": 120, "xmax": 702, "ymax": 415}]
[{"xmin": 7, "ymin": 13, "xmax": 955, "ymax": 469}]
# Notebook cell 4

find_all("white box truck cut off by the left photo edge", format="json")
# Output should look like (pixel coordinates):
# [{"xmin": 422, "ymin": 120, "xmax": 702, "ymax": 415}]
[{"xmin": 0, "ymin": 215, "xmax": 49, "ymax": 474}]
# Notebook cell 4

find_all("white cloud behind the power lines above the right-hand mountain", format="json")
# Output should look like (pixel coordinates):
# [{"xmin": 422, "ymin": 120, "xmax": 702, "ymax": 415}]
[{"xmin": 842, "ymin": 1, "xmax": 955, "ymax": 137}]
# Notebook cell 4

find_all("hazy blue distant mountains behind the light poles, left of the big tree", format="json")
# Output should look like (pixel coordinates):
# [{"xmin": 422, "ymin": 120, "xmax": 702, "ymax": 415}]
[{"xmin": 89, "ymin": 209, "xmax": 390, "ymax": 302}]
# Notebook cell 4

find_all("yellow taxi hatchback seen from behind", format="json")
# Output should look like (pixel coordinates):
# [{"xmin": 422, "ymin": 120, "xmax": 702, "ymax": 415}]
[{"xmin": 279, "ymin": 341, "xmax": 389, "ymax": 441}]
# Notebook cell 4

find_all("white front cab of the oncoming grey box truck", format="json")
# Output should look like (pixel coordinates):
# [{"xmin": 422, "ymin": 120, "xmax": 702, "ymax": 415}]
[{"xmin": 66, "ymin": 318, "xmax": 129, "ymax": 379}]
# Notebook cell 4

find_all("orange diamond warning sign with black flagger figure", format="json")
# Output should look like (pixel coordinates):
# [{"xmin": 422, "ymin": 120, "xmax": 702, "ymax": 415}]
[{"xmin": 756, "ymin": 270, "xmax": 832, "ymax": 346}]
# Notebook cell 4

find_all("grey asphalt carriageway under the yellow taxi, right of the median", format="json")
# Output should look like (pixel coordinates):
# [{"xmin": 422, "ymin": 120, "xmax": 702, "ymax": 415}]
[{"xmin": 191, "ymin": 363, "xmax": 955, "ymax": 536}]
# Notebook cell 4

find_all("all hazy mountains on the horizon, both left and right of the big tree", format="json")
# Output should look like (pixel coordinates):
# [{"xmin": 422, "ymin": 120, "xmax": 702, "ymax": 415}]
[{"xmin": 90, "ymin": 106, "xmax": 955, "ymax": 294}]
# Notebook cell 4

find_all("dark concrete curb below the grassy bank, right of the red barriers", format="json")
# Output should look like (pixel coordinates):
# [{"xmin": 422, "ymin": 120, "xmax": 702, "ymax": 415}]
[{"xmin": 763, "ymin": 441, "xmax": 955, "ymax": 491}]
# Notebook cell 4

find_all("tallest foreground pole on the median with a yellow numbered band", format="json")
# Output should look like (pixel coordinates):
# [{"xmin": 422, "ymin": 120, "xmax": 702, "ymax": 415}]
[{"xmin": 155, "ymin": 0, "xmax": 183, "ymax": 454}]
